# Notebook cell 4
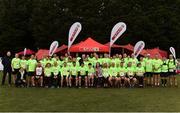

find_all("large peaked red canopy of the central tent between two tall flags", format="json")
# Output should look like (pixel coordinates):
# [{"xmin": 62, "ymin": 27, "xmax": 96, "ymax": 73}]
[{"xmin": 69, "ymin": 37, "xmax": 109, "ymax": 52}]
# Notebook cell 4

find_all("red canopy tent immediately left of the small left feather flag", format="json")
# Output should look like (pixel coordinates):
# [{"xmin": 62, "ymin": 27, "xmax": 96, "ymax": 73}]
[{"xmin": 36, "ymin": 49, "xmax": 49, "ymax": 60}]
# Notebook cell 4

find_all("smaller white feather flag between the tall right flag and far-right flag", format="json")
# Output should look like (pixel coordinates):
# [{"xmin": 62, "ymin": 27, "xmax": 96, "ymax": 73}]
[{"xmin": 134, "ymin": 41, "xmax": 145, "ymax": 57}]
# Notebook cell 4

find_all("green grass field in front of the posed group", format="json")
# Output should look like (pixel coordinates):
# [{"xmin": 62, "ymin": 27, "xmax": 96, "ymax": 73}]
[{"xmin": 0, "ymin": 72, "xmax": 180, "ymax": 112}]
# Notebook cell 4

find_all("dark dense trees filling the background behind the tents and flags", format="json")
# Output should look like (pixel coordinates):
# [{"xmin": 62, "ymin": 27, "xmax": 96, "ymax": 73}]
[{"xmin": 0, "ymin": 0, "xmax": 180, "ymax": 55}]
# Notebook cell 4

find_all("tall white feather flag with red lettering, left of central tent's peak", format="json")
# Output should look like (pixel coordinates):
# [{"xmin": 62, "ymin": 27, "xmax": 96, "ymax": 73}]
[{"xmin": 68, "ymin": 22, "xmax": 82, "ymax": 50}]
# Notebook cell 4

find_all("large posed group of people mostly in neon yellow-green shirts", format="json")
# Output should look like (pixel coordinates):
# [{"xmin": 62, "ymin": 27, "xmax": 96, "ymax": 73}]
[{"xmin": 12, "ymin": 53, "xmax": 178, "ymax": 88}]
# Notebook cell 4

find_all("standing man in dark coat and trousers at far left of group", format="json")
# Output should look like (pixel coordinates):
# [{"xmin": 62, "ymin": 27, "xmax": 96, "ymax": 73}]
[{"xmin": 2, "ymin": 51, "xmax": 12, "ymax": 85}]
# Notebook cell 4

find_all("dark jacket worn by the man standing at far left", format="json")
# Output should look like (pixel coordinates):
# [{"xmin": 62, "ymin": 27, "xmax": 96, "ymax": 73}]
[{"xmin": 2, "ymin": 56, "xmax": 12, "ymax": 72}]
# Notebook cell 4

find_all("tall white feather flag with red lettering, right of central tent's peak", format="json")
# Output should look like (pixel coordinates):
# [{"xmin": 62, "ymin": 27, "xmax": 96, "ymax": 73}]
[{"xmin": 110, "ymin": 22, "xmax": 126, "ymax": 47}]
